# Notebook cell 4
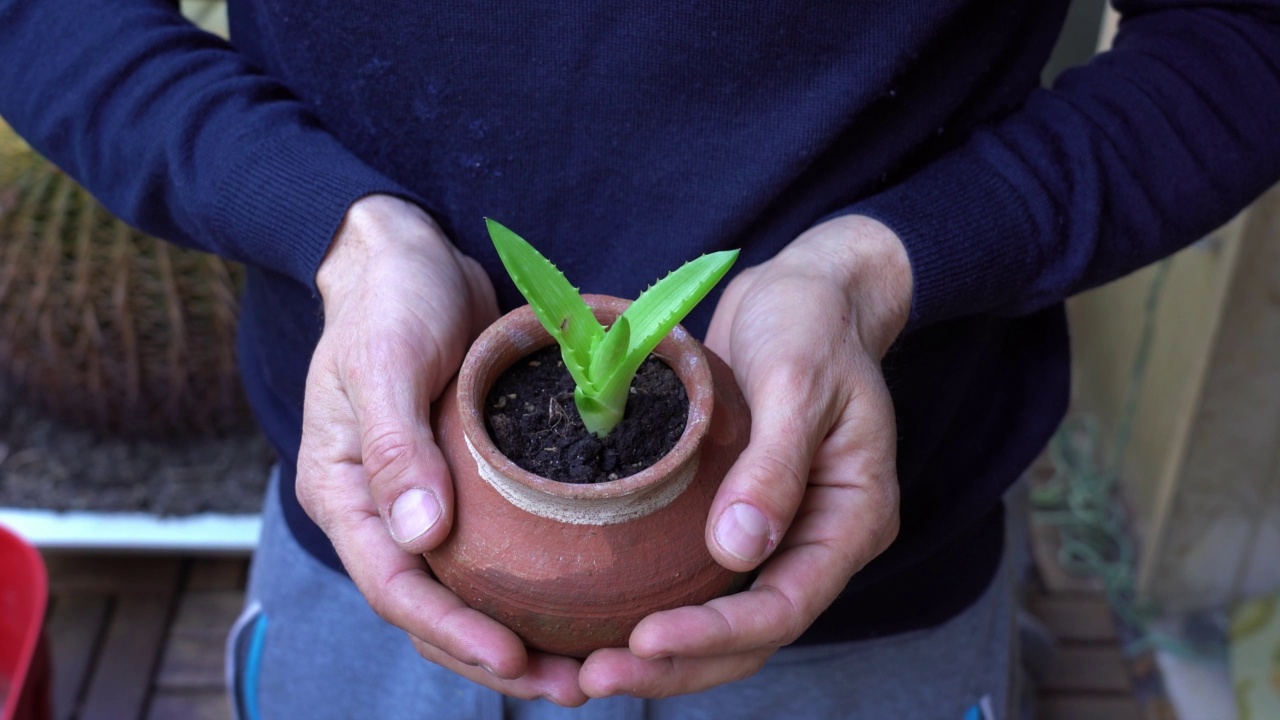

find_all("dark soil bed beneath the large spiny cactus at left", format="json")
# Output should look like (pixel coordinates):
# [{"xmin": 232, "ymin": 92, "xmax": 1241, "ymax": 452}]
[{"xmin": 0, "ymin": 384, "xmax": 275, "ymax": 515}]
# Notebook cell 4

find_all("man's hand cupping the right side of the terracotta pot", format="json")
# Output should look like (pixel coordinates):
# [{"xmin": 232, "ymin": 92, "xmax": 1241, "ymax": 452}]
[{"xmin": 580, "ymin": 217, "xmax": 911, "ymax": 697}]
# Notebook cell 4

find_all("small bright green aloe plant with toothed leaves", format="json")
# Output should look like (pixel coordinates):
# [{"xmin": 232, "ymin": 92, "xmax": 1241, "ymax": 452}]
[{"xmin": 485, "ymin": 219, "xmax": 737, "ymax": 437}]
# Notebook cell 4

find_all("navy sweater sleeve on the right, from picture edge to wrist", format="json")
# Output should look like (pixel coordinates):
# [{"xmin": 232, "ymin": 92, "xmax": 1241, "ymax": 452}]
[{"xmin": 845, "ymin": 0, "xmax": 1280, "ymax": 327}]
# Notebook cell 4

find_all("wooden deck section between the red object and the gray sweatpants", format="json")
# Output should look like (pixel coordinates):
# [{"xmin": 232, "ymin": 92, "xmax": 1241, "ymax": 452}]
[{"xmin": 46, "ymin": 555, "xmax": 248, "ymax": 720}]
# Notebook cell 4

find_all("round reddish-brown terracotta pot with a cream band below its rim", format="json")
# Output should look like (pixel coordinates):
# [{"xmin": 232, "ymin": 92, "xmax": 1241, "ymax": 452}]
[{"xmin": 426, "ymin": 296, "xmax": 750, "ymax": 657}]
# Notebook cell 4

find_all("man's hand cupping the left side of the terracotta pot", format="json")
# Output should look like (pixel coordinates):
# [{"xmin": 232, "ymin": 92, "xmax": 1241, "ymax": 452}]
[{"xmin": 297, "ymin": 196, "xmax": 586, "ymax": 705}]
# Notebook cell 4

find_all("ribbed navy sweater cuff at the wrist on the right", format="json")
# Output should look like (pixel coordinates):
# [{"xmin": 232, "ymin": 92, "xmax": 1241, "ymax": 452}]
[{"xmin": 841, "ymin": 152, "xmax": 1042, "ymax": 331}]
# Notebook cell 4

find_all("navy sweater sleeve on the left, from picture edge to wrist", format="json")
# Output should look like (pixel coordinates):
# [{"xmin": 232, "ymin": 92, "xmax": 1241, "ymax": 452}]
[{"xmin": 0, "ymin": 0, "xmax": 407, "ymax": 288}]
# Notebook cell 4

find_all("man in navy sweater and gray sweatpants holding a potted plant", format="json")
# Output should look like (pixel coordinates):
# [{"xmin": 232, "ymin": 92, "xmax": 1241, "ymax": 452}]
[{"xmin": 0, "ymin": 0, "xmax": 1280, "ymax": 717}]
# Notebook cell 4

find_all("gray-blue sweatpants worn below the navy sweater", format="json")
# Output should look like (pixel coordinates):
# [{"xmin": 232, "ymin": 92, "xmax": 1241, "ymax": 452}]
[{"xmin": 228, "ymin": 471, "xmax": 1016, "ymax": 720}]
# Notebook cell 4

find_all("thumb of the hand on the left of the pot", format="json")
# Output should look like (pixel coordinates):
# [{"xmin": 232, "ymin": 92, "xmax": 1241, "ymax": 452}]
[{"xmin": 347, "ymin": 338, "xmax": 453, "ymax": 553}]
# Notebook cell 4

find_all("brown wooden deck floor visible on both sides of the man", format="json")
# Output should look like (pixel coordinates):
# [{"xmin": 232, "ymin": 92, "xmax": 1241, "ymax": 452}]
[{"xmin": 35, "ymin": 532, "xmax": 1174, "ymax": 720}]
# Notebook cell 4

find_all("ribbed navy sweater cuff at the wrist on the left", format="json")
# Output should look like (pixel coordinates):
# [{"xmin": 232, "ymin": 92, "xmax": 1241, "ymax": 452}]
[{"xmin": 212, "ymin": 129, "xmax": 421, "ymax": 292}]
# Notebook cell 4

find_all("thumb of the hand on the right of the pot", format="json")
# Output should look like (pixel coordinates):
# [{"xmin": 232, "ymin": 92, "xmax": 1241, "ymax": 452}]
[{"xmin": 707, "ymin": 368, "xmax": 826, "ymax": 571}]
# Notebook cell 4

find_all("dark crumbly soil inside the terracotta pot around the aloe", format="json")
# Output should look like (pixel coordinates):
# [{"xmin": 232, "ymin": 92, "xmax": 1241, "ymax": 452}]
[{"xmin": 485, "ymin": 345, "xmax": 689, "ymax": 483}]
